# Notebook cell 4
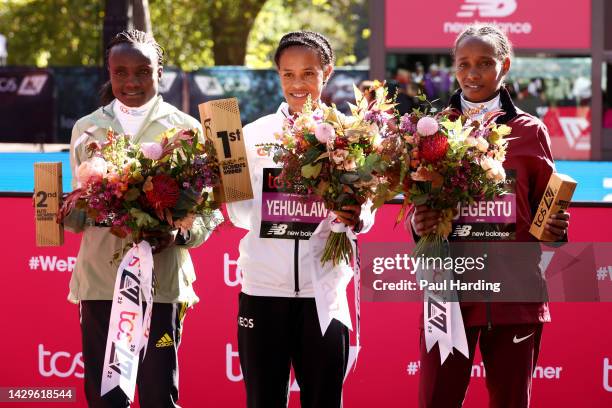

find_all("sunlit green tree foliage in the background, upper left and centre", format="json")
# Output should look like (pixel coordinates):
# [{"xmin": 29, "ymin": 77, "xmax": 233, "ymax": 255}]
[{"xmin": 0, "ymin": 0, "xmax": 369, "ymax": 67}]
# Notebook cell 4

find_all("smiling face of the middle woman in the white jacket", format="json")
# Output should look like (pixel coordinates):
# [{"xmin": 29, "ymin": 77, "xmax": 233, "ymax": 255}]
[{"xmin": 278, "ymin": 46, "xmax": 332, "ymax": 114}]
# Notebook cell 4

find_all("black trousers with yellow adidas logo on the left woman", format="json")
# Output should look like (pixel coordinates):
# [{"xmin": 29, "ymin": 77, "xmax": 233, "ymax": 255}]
[{"xmin": 81, "ymin": 300, "xmax": 187, "ymax": 408}]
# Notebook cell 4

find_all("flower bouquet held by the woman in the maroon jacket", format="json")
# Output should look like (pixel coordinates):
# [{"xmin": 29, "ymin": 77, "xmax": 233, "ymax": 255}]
[{"xmin": 393, "ymin": 101, "xmax": 511, "ymax": 254}]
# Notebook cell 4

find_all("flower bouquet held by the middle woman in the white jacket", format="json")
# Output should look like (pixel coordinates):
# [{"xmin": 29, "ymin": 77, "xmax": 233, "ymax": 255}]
[{"xmin": 262, "ymin": 87, "xmax": 393, "ymax": 265}]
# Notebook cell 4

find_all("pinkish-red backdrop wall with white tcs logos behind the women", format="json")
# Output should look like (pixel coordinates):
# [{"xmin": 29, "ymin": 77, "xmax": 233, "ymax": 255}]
[{"xmin": 0, "ymin": 198, "xmax": 612, "ymax": 408}]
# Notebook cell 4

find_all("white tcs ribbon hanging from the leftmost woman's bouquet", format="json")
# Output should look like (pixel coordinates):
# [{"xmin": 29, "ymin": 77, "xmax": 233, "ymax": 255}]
[{"xmin": 100, "ymin": 241, "xmax": 153, "ymax": 402}]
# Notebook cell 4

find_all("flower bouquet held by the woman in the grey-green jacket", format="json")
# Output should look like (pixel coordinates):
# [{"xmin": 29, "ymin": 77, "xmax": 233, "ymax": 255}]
[{"xmin": 59, "ymin": 129, "xmax": 219, "ymax": 250}]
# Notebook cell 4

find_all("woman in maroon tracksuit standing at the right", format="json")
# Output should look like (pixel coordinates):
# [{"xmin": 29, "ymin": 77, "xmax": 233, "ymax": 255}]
[{"xmin": 410, "ymin": 25, "xmax": 569, "ymax": 408}]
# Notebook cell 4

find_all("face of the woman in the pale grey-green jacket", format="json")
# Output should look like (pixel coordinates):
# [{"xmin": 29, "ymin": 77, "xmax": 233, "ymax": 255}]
[{"xmin": 108, "ymin": 43, "xmax": 163, "ymax": 107}]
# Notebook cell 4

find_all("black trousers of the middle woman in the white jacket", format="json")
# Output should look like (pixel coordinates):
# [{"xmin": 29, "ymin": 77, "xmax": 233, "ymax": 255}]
[{"xmin": 238, "ymin": 293, "xmax": 349, "ymax": 408}]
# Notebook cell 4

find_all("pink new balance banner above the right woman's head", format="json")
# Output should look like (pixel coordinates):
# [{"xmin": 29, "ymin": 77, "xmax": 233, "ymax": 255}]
[{"xmin": 385, "ymin": 0, "xmax": 591, "ymax": 49}]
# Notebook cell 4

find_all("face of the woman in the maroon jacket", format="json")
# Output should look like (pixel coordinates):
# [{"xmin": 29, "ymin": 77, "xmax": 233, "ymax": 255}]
[{"xmin": 455, "ymin": 37, "xmax": 510, "ymax": 102}]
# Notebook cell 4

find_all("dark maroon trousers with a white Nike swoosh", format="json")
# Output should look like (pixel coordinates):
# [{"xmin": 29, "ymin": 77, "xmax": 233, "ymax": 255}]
[{"xmin": 419, "ymin": 323, "xmax": 543, "ymax": 408}]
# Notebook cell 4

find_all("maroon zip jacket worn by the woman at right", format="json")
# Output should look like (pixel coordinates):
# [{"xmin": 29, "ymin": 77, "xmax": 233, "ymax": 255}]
[{"xmin": 416, "ymin": 88, "xmax": 555, "ymax": 327}]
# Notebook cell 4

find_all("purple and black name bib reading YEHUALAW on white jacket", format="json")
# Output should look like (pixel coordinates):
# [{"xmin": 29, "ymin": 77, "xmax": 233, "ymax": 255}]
[{"xmin": 259, "ymin": 168, "xmax": 328, "ymax": 240}]
